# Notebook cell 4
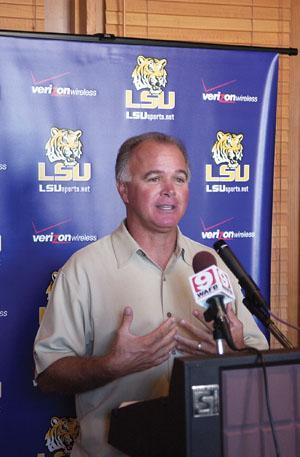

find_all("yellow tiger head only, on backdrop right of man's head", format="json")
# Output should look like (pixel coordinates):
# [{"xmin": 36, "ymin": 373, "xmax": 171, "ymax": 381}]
[{"xmin": 212, "ymin": 131, "xmax": 244, "ymax": 169}]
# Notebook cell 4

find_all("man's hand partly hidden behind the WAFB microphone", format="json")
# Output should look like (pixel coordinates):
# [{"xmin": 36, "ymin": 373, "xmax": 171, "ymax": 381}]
[{"xmin": 175, "ymin": 304, "xmax": 245, "ymax": 355}]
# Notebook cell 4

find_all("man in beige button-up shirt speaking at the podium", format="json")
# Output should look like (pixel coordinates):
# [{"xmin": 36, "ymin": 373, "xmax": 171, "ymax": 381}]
[{"xmin": 34, "ymin": 133, "xmax": 267, "ymax": 457}]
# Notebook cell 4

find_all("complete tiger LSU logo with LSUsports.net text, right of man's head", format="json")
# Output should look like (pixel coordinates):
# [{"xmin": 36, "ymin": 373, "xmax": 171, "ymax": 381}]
[{"xmin": 205, "ymin": 131, "xmax": 250, "ymax": 193}]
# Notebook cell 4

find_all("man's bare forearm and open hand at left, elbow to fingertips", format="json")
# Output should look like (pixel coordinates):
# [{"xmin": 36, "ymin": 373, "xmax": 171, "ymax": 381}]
[{"xmin": 37, "ymin": 306, "xmax": 177, "ymax": 394}]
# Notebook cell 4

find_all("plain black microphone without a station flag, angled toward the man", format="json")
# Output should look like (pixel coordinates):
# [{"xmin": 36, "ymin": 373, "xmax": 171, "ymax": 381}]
[{"xmin": 213, "ymin": 240, "xmax": 268, "ymax": 312}]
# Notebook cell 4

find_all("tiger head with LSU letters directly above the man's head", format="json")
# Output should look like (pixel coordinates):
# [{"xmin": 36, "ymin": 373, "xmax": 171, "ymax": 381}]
[{"xmin": 125, "ymin": 55, "xmax": 175, "ymax": 113}]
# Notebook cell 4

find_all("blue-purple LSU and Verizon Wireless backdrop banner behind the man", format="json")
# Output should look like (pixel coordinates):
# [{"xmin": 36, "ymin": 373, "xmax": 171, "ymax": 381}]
[{"xmin": 0, "ymin": 34, "xmax": 278, "ymax": 457}]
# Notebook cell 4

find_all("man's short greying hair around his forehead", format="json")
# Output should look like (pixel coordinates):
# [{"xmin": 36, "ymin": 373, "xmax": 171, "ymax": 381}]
[{"xmin": 115, "ymin": 132, "xmax": 191, "ymax": 182}]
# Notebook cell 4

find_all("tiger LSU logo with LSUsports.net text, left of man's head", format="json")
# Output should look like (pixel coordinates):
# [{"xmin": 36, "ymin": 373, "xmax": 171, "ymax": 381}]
[{"xmin": 38, "ymin": 127, "xmax": 91, "ymax": 192}]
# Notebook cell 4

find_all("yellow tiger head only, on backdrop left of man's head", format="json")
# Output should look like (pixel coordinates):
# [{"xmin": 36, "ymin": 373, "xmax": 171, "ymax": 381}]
[{"xmin": 45, "ymin": 127, "xmax": 82, "ymax": 167}]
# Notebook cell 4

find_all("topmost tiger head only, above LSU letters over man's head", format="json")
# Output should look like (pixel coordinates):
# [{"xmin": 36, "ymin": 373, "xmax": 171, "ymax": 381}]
[{"xmin": 131, "ymin": 56, "xmax": 167, "ymax": 95}]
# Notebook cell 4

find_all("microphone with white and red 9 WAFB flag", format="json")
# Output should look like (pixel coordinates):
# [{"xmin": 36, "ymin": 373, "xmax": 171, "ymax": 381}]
[{"xmin": 189, "ymin": 251, "xmax": 236, "ymax": 354}]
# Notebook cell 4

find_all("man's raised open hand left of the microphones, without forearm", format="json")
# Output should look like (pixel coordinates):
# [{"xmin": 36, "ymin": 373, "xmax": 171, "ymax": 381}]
[{"xmin": 108, "ymin": 306, "xmax": 177, "ymax": 377}]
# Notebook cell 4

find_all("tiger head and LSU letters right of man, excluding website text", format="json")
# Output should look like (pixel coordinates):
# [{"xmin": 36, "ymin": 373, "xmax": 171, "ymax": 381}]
[{"xmin": 205, "ymin": 130, "xmax": 250, "ymax": 182}]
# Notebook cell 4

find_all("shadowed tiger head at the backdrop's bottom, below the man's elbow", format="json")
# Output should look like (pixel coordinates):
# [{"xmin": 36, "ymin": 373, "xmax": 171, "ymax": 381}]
[{"xmin": 45, "ymin": 417, "xmax": 79, "ymax": 457}]
